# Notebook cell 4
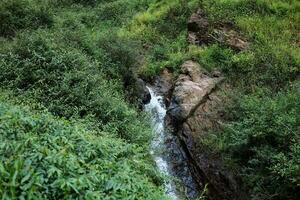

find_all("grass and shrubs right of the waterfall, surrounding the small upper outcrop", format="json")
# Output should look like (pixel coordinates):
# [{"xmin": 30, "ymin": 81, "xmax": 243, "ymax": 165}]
[{"xmin": 120, "ymin": 0, "xmax": 300, "ymax": 199}]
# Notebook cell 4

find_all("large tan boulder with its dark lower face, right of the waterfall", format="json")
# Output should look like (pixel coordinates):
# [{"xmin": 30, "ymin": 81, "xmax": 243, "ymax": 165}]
[{"xmin": 168, "ymin": 61, "xmax": 247, "ymax": 200}]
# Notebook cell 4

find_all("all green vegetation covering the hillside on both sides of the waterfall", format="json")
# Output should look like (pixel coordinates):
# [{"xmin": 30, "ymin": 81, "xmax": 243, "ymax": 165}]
[{"xmin": 0, "ymin": 0, "xmax": 300, "ymax": 199}]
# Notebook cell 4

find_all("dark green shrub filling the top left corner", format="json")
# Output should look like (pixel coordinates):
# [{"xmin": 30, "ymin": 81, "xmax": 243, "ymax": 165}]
[{"xmin": 0, "ymin": 0, "xmax": 53, "ymax": 37}]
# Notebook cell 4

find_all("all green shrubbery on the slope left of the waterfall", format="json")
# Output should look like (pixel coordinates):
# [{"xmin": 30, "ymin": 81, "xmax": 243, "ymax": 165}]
[{"xmin": 0, "ymin": 0, "xmax": 165, "ymax": 199}]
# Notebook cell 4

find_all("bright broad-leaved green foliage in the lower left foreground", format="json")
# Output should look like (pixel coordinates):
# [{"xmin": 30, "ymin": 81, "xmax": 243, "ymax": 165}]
[{"xmin": 0, "ymin": 94, "xmax": 163, "ymax": 199}]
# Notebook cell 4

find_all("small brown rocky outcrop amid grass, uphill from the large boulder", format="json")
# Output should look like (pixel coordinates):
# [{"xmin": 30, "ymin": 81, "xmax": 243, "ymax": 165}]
[{"xmin": 188, "ymin": 9, "xmax": 249, "ymax": 51}]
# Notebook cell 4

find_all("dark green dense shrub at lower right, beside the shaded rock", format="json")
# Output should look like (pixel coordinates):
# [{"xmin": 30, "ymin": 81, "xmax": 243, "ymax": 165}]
[{"xmin": 223, "ymin": 84, "xmax": 300, "ymax": 199}]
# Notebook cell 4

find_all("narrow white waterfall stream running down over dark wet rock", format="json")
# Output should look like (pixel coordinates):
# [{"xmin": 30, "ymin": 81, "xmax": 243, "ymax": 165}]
[{"xmin": 145, "ymin": 87, "xmax": 199, "ymax": 200}]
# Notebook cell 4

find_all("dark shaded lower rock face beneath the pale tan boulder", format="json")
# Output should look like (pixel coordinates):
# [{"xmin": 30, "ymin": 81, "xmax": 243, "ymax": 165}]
[{"xmin": 178, "ymin": 115, "xmax": 249, "ymax": 200}]
